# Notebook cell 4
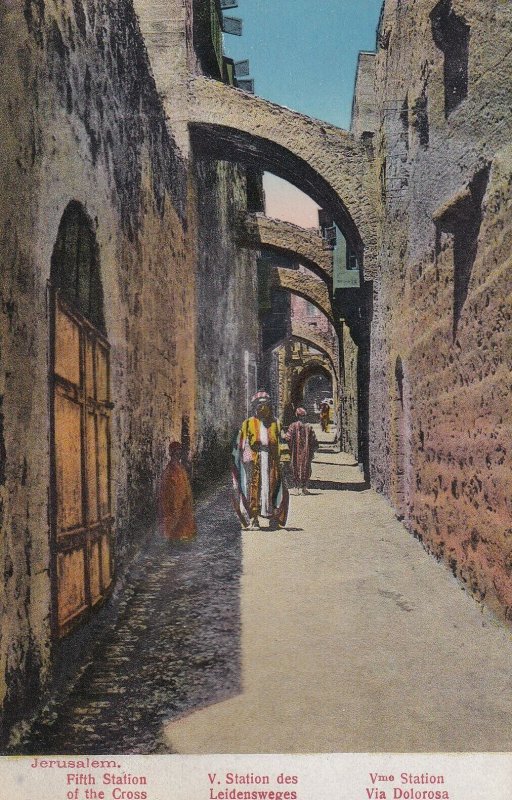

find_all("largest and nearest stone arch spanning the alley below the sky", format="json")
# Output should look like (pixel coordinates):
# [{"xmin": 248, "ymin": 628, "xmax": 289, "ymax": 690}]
[{"xmin": 189, "ymin": 77, "xmax": 378, "ymax": 274}]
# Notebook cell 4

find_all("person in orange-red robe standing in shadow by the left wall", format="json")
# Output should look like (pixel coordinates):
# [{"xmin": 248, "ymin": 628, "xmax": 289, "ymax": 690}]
[{"xmin": 158, "ymin": 442, "xmax": 196, "ymax": 541}]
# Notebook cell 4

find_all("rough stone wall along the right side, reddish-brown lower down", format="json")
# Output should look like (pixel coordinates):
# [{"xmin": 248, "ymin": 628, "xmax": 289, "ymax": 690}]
[{"xmin": 371, "ymin": 0, "xmax": 512, "ymax": 618}]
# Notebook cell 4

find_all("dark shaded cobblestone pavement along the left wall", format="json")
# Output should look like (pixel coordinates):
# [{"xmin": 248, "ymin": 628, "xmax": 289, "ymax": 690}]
[{"xmin": 16, "ymin": 486, "xmax": 241, "ymax": 754}]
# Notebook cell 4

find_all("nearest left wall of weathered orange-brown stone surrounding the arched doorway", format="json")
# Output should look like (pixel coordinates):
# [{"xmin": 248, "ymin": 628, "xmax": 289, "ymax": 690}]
[{"xmin": 0, "ymin": 2, "xmax": 195, "ymax": 736}]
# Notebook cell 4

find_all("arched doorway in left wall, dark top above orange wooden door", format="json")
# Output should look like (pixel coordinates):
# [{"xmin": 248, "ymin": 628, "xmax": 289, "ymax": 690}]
[{"xmin": 50, "ymin": 202, "xmax": 113, "ymax": 637}]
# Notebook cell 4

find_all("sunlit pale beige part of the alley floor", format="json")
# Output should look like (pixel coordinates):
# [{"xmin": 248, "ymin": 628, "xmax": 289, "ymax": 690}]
[{"xmin": 165, "ymin": 432, "xmax": 512, "ymax": 753}]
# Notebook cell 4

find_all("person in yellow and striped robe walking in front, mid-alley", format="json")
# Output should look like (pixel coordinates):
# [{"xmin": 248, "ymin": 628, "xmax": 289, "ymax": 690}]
[{"xmin": 232, "ymin": 390, "xmax": 288, "ymax": 530}]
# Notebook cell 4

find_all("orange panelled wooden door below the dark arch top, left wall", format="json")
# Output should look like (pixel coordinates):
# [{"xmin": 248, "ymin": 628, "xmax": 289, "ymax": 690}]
[{"xmin": 52, "ymin": 292, "xmax": 113, "ymax": 636}]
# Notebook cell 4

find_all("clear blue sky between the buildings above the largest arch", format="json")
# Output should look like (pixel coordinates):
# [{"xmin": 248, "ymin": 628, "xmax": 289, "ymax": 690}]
[{"xmin": 224, "ymin": 0, "xmax": 382, "ymax": 128}]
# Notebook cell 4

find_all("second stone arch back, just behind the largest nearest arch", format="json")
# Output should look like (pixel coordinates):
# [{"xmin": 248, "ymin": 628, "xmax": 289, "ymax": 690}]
[{"xmin": 238, "ymin": 214, "xmax": 333, "ymax": 288}]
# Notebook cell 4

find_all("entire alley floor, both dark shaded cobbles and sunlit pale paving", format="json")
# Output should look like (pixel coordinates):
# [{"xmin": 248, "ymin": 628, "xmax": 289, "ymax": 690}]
[{"xmin": 21, "ymin": 428, "xmax": 512, "ymax": 753}]
